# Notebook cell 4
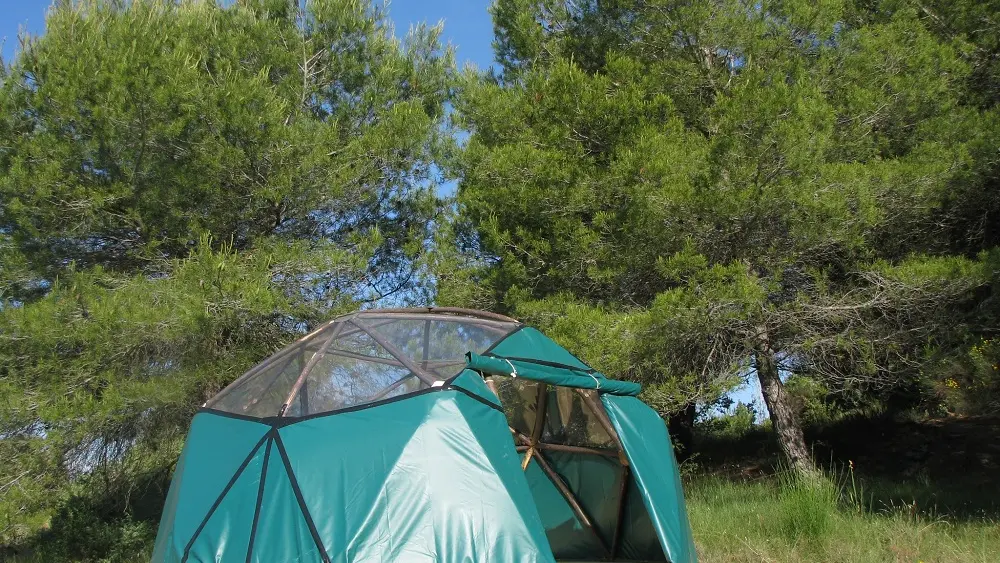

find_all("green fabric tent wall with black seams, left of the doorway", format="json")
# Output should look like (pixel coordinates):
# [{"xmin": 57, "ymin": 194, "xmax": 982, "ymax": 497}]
[{"xmin": 153, "ymin": 387, "xmax": 554, "ymax": 563}]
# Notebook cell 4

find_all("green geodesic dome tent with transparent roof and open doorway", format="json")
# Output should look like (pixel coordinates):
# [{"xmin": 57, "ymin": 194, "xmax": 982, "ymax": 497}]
[{"xmin": 153, "ymin": 308, "xmax": 695, "ymax": 563}]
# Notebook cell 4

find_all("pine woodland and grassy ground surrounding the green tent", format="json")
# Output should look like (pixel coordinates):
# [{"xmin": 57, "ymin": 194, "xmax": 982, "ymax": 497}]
[{"xmin": 0, "ymin": 0, "xmax": 1000, "ymax": 561}]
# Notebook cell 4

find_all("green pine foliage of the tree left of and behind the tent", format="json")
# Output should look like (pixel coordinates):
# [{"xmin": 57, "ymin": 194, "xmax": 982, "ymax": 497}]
[{"xmin": 0, "ymin": 0, "xmax": 452, "ymax": 557}]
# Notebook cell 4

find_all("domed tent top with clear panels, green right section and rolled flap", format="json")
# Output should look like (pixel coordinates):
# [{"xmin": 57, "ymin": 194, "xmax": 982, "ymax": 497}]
[{"xmin": 205, "ymin": 307, "xmax": 639, "ymax": 418}]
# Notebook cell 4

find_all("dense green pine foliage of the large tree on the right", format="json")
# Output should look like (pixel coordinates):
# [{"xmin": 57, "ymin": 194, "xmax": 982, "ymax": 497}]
[{"xmin": 454, "ymin": 0, "xmax": 1000, "ymax": 474}]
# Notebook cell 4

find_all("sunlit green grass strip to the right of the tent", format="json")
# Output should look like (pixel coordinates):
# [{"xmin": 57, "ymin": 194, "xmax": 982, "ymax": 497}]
[{"xmin": 686, "ymin": 472, "xmax": 1000, "ymax": 563}]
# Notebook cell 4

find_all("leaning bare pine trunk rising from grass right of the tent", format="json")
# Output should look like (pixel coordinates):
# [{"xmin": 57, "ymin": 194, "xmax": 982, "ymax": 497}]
[{"xmin": 754, "ymin": 336, "xmax": 816, "ymax": 476}]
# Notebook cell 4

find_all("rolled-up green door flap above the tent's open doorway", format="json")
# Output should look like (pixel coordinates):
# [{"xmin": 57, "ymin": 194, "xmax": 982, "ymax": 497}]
[{"xmin": 465, "ymin": 352, "xmax": 642, "ymax": 396}]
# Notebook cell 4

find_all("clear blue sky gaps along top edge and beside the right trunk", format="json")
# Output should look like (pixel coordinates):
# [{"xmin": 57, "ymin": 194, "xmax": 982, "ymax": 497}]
[{"xmin": 0, "ymin": 0, "xmax": 766, "ymax": 413}]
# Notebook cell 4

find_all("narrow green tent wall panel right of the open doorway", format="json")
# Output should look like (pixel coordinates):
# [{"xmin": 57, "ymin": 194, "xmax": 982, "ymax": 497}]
[{"xmin": 601, "ymin": 395, "xmax": 697, "ymax": 563}]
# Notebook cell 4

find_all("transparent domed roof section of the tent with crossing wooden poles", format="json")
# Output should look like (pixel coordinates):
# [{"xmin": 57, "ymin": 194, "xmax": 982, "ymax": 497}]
[{"xmin": 208, "ymin": 313, "xmax": 517, "ymax": 417}]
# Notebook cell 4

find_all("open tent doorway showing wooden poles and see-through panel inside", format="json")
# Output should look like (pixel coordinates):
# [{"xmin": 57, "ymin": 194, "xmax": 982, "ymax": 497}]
[{"xmin": 490, "ymin": 376, "xmax": 666, "ymax": 561}]
